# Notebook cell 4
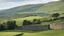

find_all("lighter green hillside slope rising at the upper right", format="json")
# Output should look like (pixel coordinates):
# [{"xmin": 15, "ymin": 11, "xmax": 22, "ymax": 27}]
[{"xmin": 37, "ymin": 1, "xmax": 64, "ymax": 13}]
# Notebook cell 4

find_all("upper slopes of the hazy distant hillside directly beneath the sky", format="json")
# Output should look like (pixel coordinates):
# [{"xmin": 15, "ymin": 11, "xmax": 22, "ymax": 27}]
[{"xmin": 0, "ymin": 1, "xmax": 64, "ymax": 14}]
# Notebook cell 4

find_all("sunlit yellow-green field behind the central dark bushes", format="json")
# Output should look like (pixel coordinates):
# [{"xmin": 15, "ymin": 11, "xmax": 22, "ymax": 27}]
[{"xmin": 13, "ymin": 16, "xmax": 43, "ymax": 26}]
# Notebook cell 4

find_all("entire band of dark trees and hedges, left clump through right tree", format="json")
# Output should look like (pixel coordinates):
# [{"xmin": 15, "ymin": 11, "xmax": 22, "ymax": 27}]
[{"xmin": 0, "ymin": 13, "xmax": 64, "ymax": 31}]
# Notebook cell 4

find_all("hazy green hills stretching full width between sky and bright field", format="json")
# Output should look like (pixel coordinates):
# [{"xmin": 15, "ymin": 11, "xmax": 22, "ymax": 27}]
[{"xmin": 0, "ymin": 1, "xmax": 64, "ymax": 19}]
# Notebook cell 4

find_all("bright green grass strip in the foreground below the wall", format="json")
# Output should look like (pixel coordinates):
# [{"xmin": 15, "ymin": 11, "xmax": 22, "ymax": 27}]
[{"xmin": 0, "ymin": 30, "xmax": 64, "ymax": 36}]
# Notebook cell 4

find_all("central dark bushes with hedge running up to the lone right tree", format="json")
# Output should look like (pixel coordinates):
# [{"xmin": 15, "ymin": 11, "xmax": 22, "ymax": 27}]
[{"xmin": 23, "ymin": 13, "xmax": 64, "ymax": 25}]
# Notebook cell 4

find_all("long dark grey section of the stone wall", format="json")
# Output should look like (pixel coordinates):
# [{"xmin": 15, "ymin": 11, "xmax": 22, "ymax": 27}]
[{"xmin": 18, "ymin": 25, "xmax": 50, "ymax": 31}]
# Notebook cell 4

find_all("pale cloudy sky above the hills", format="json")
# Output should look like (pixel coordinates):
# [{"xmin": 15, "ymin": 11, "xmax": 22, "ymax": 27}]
[{"xmin": 0, "ymin": 0, "xmax": 58, "ymax": 10}]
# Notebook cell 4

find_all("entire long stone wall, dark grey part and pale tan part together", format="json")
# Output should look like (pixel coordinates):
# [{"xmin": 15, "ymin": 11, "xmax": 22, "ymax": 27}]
[{"xmin": 18, "ymin": 24, "xmax": 64, "ymax": 31}]
